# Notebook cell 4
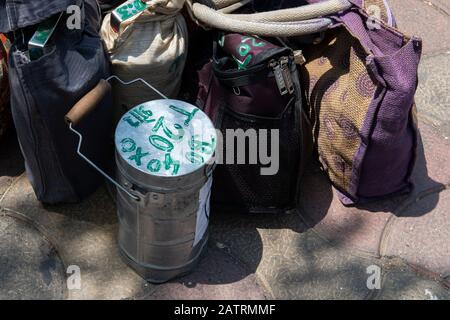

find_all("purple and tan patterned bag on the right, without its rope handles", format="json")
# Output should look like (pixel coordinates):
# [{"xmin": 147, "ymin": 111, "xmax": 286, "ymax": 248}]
[{"xmin": 301, "ymin": 0, "xmax": 422, "ymax": 205}]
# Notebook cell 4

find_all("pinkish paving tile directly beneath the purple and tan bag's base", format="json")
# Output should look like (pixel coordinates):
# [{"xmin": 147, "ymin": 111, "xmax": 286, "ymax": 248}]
[{"xmin": 300, "ymin": 121, "xmax": 450, "ymax": 256}]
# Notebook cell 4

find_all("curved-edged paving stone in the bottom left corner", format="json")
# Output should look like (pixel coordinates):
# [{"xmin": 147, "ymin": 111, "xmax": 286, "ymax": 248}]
[{"xmin": 0, "ymin": 211, "xmax": 67, "ymax": 300}]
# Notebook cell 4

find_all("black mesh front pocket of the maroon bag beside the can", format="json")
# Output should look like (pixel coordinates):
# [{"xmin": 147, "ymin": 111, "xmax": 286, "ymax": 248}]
[{"xmin": 212, "ymin": 103, "xmax": 300, "ymax": 212}]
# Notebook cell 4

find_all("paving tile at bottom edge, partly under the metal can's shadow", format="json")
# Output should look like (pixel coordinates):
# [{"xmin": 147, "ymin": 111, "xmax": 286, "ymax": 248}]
[{"xmin": 145, "ymin": 241, "xmax": 267, "ymax": 300}]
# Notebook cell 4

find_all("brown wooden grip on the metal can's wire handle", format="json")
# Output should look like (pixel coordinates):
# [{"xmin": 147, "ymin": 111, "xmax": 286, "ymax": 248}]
[{"xmin": 64, "ymin": 79, "xmax": 111, "ymax": 125}]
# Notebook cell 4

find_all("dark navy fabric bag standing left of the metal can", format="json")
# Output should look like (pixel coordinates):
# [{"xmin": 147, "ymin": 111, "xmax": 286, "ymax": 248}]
[{"xmin": 2, "ymin": 1, "xmax": 112, "ymax": 203}]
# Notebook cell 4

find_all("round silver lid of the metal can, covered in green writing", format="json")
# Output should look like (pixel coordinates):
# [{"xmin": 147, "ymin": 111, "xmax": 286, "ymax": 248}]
[{"xmin": 115, "ymin": 99, "xmax": 217, "ymax": 177}]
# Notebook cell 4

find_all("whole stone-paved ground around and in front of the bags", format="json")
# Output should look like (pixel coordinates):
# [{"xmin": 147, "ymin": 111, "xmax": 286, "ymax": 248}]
[{"xmin": 0, "ymin": 0, "xmax": 450, "ymax": 299}]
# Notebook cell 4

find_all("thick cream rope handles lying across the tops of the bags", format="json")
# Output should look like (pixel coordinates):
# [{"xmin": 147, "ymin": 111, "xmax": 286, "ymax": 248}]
[{"xmin": 192, "ymin": 0, "xmax": 352, "ymax": 37}]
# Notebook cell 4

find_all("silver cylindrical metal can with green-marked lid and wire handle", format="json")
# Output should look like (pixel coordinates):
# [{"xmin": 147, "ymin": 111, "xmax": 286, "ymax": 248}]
[{"xmin": 66, "ymin": 77, "xmax": 217, "ymax": 283}]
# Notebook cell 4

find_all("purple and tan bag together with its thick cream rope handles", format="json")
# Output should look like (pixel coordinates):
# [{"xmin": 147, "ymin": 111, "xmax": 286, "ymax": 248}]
[{"xmin": 187, "ymin": 0, "xmax": 422, "ymax": 205}]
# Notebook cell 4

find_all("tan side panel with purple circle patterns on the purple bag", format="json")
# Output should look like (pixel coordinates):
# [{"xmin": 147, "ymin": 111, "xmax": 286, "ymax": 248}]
[{"xmin": 302, "ymin": 28, "xmax": 376, "ymax": 190}]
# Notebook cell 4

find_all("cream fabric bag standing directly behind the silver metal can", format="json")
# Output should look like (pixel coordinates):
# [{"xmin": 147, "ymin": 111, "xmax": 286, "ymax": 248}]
[{"xmin": 101, "ymin": 0, "xmax": 188, "ymax": 119}]
